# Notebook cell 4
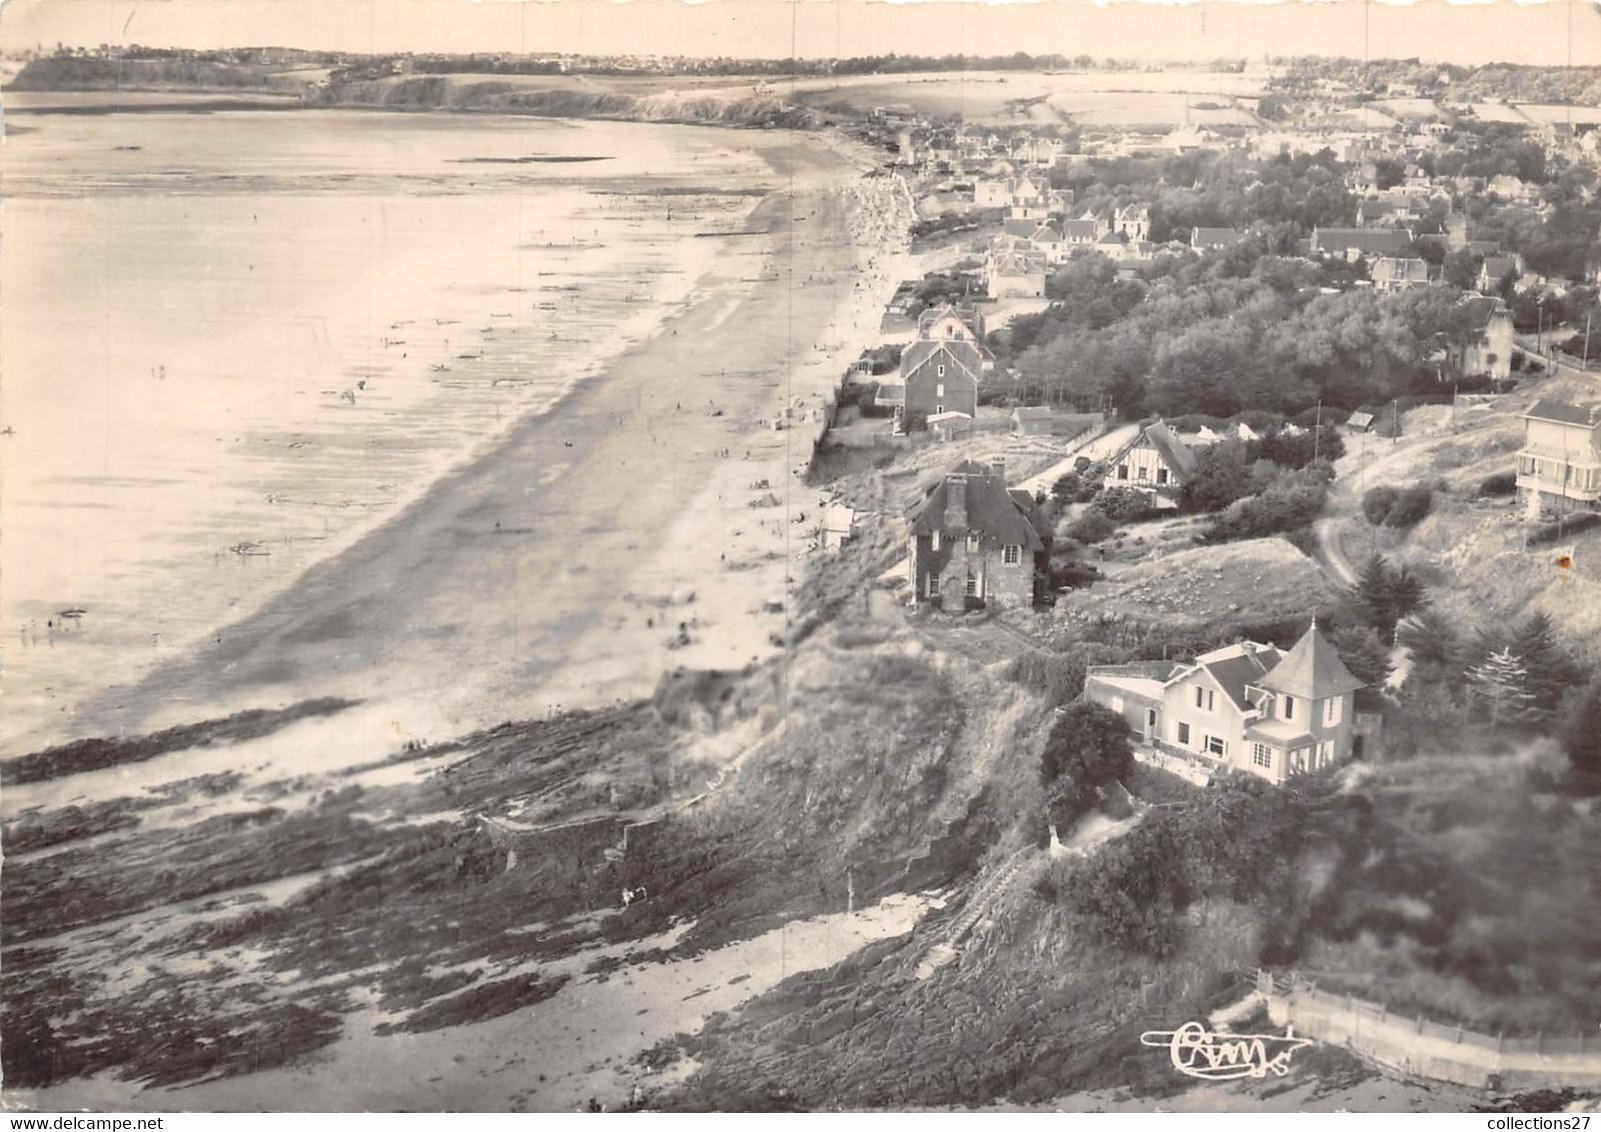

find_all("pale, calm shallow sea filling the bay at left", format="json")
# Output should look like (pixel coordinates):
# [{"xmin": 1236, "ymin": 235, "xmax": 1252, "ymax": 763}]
[{"xmin": 0, "ymin": 102, "xmax": 767, "ymax": 753}]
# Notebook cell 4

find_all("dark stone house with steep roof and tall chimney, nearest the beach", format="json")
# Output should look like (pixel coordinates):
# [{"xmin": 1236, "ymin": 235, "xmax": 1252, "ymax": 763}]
[{"xmin": 906, "ymin": 460, "xmax": 1049, "ymax": 612}]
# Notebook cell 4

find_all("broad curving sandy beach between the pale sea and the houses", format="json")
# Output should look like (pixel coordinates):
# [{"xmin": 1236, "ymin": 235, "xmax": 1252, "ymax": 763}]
[{"xmin": 0, "ymin": 108, "xmax": 906, "ymax": 759}]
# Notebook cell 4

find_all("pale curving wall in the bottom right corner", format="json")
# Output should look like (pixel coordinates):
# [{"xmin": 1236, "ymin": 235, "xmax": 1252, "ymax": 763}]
[{"xmin": 1257, "ymin": 970, "xmax": 1601, "ymax": 1090}]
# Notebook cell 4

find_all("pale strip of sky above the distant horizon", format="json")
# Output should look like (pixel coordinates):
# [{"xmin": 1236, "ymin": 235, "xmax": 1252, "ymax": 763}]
[{"xmin": 9, "ymin": 0, "xmax": 1601, "ymax": 66}]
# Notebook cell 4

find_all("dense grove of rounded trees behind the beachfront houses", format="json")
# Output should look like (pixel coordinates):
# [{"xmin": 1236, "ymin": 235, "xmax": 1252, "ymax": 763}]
[{"xmin": 993, "ymin": 240, "xmax": 1492, "ymax": 416}]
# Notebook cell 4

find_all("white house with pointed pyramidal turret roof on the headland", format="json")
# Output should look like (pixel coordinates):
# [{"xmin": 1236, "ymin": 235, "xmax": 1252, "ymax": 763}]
[{"xmin": 1084, "ymin": 621, "xmax": 1364, "ymax": 783}]
